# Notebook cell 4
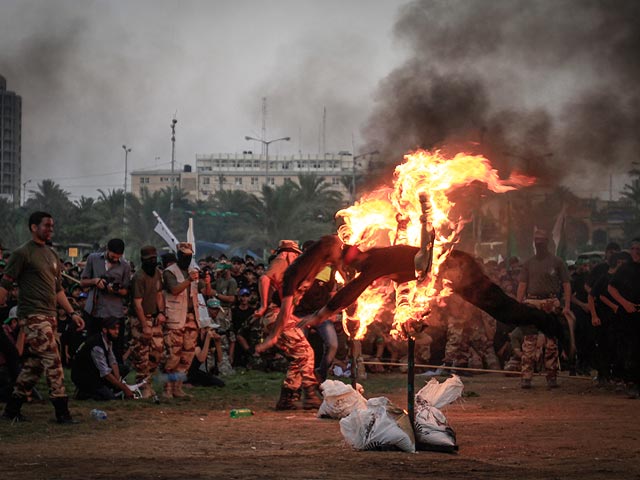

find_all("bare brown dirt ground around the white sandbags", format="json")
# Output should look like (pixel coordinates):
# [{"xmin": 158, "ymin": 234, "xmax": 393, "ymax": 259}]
[{"xmin": 0, "ymin": 374, "xmax": 640, "ymax": 480}]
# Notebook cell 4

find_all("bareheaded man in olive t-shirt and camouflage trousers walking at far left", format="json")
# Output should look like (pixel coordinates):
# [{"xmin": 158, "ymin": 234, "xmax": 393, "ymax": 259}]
[{"xmin": 0, "ymin": 212, "xmax": 84, "ymax": 424}]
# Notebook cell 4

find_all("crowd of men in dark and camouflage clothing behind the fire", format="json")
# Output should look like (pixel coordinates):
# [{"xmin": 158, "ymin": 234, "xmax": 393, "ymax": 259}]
[{"xmin": 0, "ymin": 212, "xmax": 640, "ymax": 423}]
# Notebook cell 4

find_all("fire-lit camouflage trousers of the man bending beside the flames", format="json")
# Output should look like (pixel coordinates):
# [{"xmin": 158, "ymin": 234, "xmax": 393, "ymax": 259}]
[{"xmin": 276, "ymin": 317, "xmax": 318, "ymax": 390}]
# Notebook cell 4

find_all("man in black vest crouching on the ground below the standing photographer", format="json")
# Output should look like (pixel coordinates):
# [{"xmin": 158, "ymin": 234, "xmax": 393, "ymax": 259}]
[{"xmin": 71, "ymin": 317, "xmax": 133, "ymax": 400}]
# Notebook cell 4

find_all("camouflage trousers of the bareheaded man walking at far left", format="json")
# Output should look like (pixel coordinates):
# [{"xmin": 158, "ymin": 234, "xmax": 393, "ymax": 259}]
[{"xmin": 13, "ymin": 315, "xmax": 67, "ymax": 398}]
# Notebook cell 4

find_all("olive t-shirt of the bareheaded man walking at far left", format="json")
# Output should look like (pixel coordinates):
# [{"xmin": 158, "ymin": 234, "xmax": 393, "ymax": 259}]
[{"xmin": 2, "ymin": 240, "xmax": 62, "ymax": 318}]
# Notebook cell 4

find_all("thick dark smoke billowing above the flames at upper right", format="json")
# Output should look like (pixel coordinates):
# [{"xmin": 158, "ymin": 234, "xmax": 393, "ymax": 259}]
[{"xmin": 363, "ymin": 0, "xmax": 640, "ymax": 188}]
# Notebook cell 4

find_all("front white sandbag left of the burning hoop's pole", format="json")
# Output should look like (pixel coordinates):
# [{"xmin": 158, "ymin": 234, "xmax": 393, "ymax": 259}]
[{"xmin": 340, "ymin": 397, "xmax": 416, "ymax": 453}]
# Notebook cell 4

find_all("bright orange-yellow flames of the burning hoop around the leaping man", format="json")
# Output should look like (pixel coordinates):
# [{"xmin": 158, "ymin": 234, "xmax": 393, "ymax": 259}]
[{"xmin": 336, "ymin": 150, "xmax": 535, "ymax": 339}]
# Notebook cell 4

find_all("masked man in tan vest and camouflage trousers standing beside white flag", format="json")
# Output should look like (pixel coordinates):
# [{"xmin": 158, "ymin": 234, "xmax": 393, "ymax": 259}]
[{"xmin": 162, "ymin": 243, "xmax": 212, "ymax": 398}]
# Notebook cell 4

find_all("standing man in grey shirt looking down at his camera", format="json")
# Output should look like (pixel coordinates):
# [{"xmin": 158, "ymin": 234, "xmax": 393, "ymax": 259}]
[{"xmin": 80, "ymin": 238, "xmax": 131, "ymax": 363}]
